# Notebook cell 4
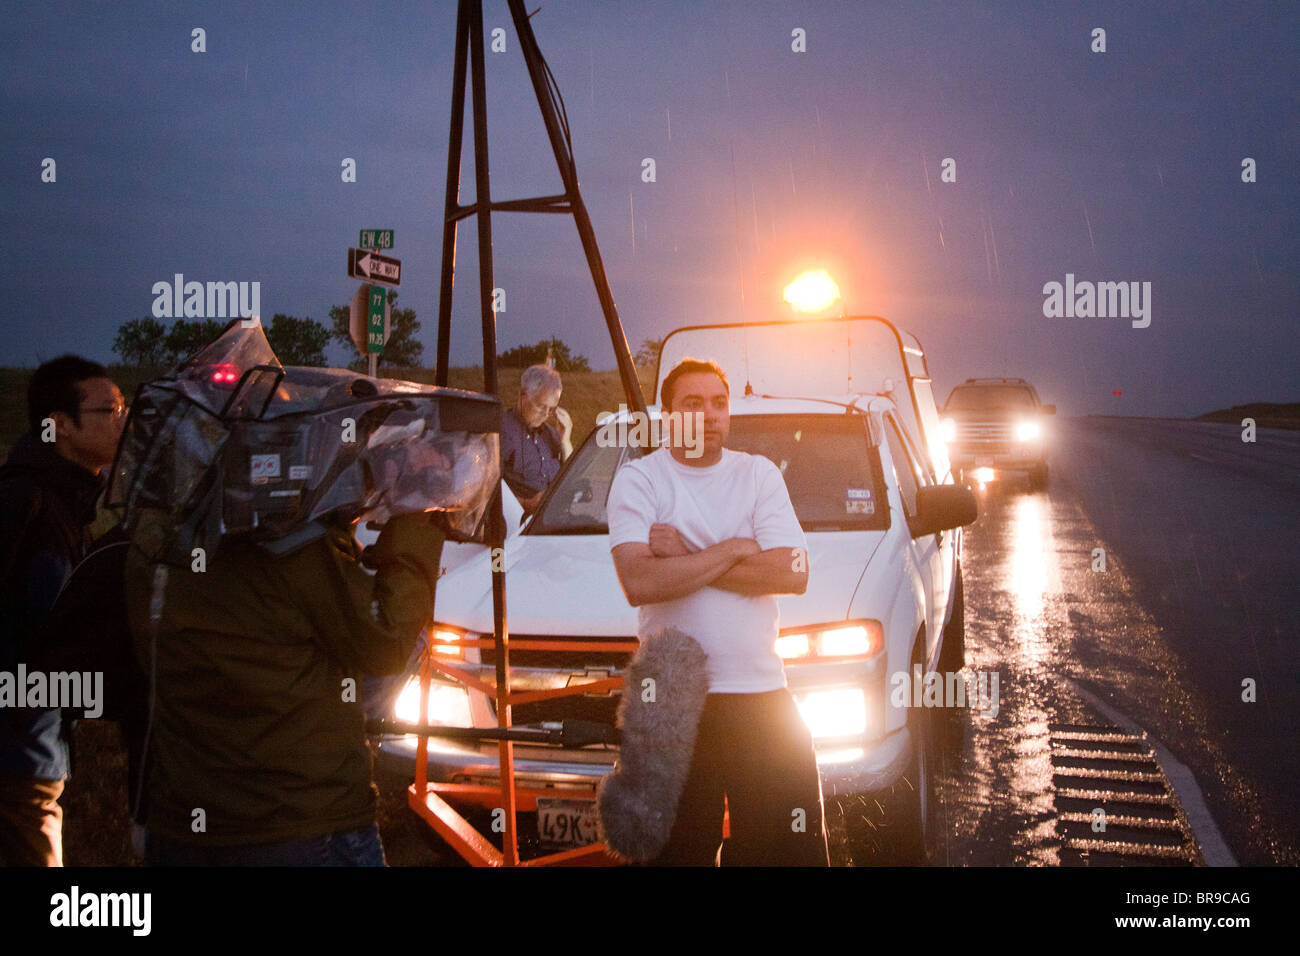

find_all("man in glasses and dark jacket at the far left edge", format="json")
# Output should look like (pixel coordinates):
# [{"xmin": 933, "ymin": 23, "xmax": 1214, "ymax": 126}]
[{"xmin": 0, "ymin": 355, "xmax": 126, "ymax": 866}]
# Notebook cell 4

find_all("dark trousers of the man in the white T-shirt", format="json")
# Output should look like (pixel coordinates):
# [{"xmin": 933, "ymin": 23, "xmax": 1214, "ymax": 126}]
[{"xmin": 651, "ymin": 689, "xmax": 829, "ymax": 866}]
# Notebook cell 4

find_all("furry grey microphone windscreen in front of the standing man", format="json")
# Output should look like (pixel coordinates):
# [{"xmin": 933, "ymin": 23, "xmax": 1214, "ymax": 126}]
[{"xmin": 597, "ymin": 628, "xmax": 709, "ymax": 862}]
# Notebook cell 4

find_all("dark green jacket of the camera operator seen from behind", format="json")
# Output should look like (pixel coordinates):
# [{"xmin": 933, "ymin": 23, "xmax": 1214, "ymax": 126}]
[{"xmin": 126, "ymin": 516, "xmax": 443, "ymax": 845}]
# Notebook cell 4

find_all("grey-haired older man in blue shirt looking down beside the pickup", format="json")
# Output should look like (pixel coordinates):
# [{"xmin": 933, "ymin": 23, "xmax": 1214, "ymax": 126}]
[{"xmin": 501, "ymin": 365, "xmax": 573, "ymax": 512}]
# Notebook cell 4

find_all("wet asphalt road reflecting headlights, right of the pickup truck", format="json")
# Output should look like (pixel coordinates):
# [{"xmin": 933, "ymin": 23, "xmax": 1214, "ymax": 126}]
[{"xmin": 936, "ymin": 418, "xmax": 1300, "ymax": 865}]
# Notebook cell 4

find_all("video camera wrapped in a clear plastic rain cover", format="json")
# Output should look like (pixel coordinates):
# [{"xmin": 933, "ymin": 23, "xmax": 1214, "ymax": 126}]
[{"xmin": 107, "ymin": 320, "xmax": 501, "ymax": 567}]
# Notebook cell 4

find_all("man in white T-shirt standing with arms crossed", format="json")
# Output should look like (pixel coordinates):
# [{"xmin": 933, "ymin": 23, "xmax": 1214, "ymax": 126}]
[{"xmin": 607, "ymin": 359, "xmax": 827, "ymax": 866}]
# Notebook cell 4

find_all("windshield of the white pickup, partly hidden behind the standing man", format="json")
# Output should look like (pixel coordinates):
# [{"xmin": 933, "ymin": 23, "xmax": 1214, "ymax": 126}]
[{"xmin": 527, "ymin": 415, "xmax": 888, "ymax": 535}]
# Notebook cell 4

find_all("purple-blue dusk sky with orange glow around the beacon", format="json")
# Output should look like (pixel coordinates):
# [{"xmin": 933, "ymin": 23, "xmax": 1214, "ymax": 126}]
[{"xmin": 0, "ymin": 0, "xmax": 1300, "ymax": 416}]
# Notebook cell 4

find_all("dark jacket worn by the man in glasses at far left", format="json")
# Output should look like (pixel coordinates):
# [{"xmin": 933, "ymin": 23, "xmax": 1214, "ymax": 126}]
[{"xmin": 0, "ymin": 432, "xmax": 103, "ymax": 779}]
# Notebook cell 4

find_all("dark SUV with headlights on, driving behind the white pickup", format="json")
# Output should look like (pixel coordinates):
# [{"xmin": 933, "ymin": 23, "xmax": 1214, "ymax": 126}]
[{"xmin": 943, "ymin": 378, "xmax": 1056, "ymax": 490}]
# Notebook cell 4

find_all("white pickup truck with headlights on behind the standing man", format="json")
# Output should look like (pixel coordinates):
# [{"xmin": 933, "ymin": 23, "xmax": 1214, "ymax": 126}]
[{"xmin": 381, "ymin": 317, "xmax": 975, "ymax": 861}]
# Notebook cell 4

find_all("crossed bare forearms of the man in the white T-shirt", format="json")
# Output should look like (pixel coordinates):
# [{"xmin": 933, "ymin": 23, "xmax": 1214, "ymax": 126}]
[{"xmin": 612, "ymin": 524, "xmax": 809, "ymax": 607}]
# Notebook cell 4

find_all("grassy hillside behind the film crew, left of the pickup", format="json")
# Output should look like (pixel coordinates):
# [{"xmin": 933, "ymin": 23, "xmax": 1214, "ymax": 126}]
[{"xmin": 0, "ymin": 365, "xmax": 653, "ymax": 455}]
